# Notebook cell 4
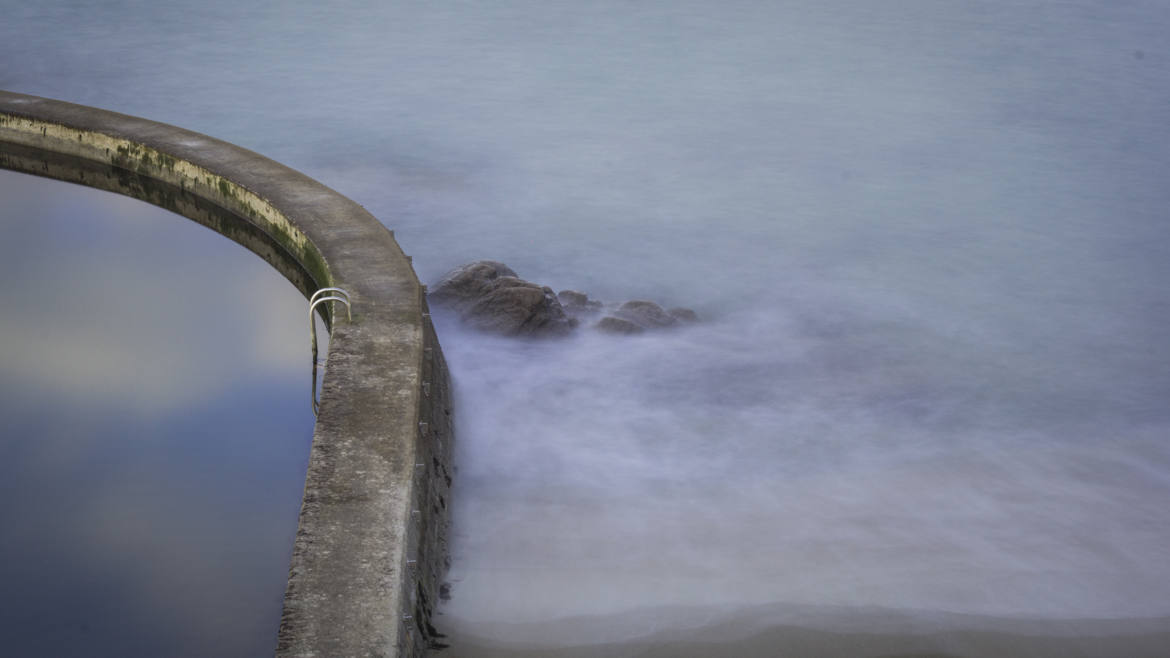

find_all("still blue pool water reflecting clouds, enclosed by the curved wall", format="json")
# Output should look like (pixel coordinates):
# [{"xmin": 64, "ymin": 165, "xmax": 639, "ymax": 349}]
[{"xmin": 0, "ymin": 171, "xmax": 312, "ymax": 657}]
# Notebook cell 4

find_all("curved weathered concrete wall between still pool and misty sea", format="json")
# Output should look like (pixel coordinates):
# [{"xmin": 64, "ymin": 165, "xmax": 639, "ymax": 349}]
[{"xmin": 0, "ymin": 91, "xmax": 453, "ymax": 657}]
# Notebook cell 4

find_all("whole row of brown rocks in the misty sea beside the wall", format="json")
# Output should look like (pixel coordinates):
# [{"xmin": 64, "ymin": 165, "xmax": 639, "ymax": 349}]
[{"xmin": 428, "ymin": 260, "xmax": 698, "ymax": 336}]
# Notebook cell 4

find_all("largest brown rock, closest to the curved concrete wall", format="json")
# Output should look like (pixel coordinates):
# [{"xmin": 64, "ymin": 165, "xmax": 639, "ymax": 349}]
[{"xmin": 429, "ymin": 260, "xmax": 573, "ymax": 336}]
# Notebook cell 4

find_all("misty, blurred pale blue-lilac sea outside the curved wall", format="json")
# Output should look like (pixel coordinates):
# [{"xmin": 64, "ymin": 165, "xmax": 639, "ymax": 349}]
[{"xmin": 0, "ymin": 0, "xmax": 1170, "ymax": 656}]
